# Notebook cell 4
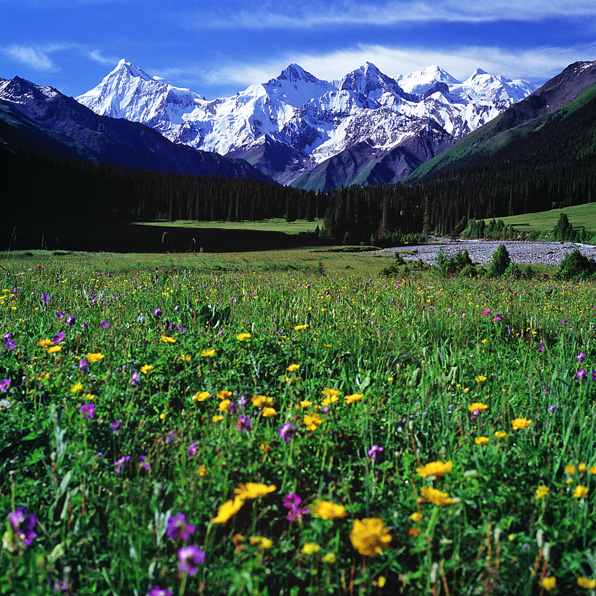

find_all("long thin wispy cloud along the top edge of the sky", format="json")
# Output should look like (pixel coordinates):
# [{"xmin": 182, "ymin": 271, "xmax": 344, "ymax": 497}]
[{"xmin": 182, "ymin": 0, "xmax": 596, "ymax": 30}]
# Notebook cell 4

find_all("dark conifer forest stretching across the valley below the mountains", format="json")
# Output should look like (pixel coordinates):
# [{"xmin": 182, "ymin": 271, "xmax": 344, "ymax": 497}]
[{"xmin": 0, "ymin": 84, "xmax": 596, "ymax": 245}]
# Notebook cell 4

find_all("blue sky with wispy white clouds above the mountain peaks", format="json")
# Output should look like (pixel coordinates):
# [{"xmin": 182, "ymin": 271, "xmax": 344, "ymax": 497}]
[{"xmin": 0, "ymin": 0, "xmax": 596, "ymax": 99}]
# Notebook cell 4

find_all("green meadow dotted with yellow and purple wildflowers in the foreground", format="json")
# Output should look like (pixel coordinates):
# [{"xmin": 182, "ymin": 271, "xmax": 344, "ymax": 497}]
[{"xmin": 0, "ymin": 257, "xmax": 596, "ymax": 596}]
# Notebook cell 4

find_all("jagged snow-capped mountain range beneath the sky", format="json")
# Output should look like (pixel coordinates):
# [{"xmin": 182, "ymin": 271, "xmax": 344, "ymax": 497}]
[{"xmin": 76, "ymin": 60, "xmax": 535, "ymax": 189}]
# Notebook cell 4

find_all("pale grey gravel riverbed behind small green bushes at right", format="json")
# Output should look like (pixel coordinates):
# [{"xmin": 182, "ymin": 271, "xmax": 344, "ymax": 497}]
[{"xmin": 368, "ymin": 240, "xmax": 596, "ymax": 266}]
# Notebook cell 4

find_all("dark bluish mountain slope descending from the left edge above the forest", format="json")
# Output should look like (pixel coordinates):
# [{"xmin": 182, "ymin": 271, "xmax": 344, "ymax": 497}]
[{"xmin": 0, "ymin": 77, "xmax": 265, "ymax": 179}]
